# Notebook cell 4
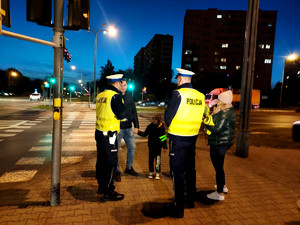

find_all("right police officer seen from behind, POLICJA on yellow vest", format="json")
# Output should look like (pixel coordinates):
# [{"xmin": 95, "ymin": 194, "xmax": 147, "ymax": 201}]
[{"xmin": 165, "ymin": 69, "xmax": 208, "ymax": 218}]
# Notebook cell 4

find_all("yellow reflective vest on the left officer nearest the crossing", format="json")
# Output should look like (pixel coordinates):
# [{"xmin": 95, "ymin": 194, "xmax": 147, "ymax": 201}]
[{"xmin": 96, "ymin": 90, "xmax": 120, "ymax": 132}]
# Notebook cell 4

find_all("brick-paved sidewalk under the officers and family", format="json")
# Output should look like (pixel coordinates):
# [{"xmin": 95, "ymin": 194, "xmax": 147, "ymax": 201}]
[{"xmin": 0, "ymin": 105, "xmax": 300, "ymax": 225}]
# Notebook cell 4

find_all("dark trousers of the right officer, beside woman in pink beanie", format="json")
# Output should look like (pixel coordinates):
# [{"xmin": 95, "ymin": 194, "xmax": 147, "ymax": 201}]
[{"xmin": 170, "ymin": 135, "xmax": 198, "ymax": 210}]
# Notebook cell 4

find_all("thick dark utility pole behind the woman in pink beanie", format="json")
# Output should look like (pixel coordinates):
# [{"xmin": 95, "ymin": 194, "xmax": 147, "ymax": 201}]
[{"xmin": 235, "ymin": 0, "xmax": 259, "ymax": 158}]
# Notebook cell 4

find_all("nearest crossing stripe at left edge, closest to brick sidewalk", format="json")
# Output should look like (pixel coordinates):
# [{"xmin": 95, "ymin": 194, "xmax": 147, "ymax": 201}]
[{"xmin": 0, "ymin": 170, "xmax": 37, "ymax": 184}]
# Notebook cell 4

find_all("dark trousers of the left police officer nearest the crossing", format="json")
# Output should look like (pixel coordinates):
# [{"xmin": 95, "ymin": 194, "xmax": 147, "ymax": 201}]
[{"xmin": 95, "ymin": 130, "xmax": 118, "ymax": 194}]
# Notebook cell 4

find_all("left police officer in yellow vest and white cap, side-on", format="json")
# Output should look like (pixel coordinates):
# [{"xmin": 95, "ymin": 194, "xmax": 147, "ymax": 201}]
[{"xmin": 95, "ymin": 74, "xmax": 125, "ymax": 201}]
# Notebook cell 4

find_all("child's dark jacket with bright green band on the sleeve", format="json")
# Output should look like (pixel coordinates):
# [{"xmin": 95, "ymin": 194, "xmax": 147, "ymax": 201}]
[{"xmin": 138, "ymin": 122, "xmax": 168, "ymax": 149}]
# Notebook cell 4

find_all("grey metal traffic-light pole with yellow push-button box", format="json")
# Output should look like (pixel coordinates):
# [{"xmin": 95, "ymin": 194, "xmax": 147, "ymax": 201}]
[{"xmin": 50, "ymin": 0, "xmax": 64, "ymax": 206}]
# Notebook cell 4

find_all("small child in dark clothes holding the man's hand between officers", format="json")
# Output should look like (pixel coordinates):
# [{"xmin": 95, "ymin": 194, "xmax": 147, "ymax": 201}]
[{"xmin": 138, "ymin": 115, "xmax": 168, "ymax": 180}]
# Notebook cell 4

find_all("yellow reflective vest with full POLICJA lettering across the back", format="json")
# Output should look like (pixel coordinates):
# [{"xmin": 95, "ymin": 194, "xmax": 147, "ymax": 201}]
[{"xmin": 169, "ymin": 88, "xmax": 206, "ymax": 136}]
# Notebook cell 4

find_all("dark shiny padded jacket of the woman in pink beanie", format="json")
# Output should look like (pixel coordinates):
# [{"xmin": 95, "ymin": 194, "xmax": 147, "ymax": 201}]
[{"xmin": 206, "ymin": 107, "xmax": 235, "ymax": 146}]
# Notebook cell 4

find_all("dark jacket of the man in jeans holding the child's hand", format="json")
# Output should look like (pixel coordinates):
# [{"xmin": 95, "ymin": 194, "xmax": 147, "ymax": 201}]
[{"xmin": 120, "ymin": 93, "xmax": 140, "ymax": 129}]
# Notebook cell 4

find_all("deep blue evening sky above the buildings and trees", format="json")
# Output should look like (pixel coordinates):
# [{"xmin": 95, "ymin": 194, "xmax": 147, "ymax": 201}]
[{"xmin": 0, "ymin": 0, "xmax": 300, "ymax": 90}]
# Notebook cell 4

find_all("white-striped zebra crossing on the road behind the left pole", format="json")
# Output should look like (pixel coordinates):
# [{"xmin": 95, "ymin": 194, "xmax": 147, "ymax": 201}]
[{"xmin": 0, "ymin": 111, "xmax": 152, "ymax": 183}]
